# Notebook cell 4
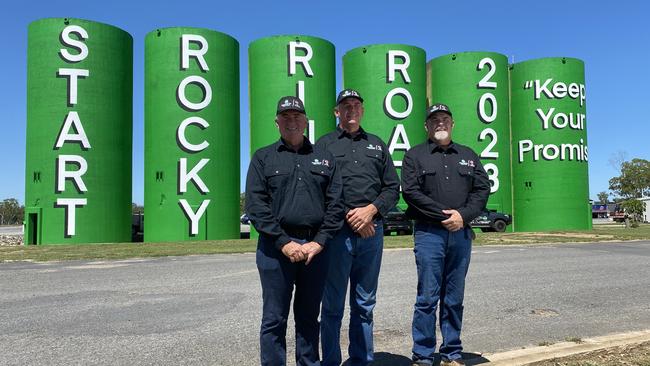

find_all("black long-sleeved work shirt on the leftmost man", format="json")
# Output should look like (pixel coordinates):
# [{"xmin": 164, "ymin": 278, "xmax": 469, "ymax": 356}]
[{"xmin": 246, "ymin": 138, "xmax": 344, "ymax": 249}]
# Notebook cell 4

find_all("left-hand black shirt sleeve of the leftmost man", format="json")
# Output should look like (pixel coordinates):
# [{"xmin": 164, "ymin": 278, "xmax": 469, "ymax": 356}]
[{"xmin": 246, "ymin": 152, "xmax": 291, "ymax": 249}]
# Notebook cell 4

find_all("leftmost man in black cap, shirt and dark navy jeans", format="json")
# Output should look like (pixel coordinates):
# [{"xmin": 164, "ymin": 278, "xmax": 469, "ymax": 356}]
[{"xmin": 246, "ymin": 96, "xmax": 344, "ymax": 366}]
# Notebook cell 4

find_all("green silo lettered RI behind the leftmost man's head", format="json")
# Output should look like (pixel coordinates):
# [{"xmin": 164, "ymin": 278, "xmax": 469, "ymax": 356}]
[{"xmin": 248, "ymin": 35, "xmax": 336, "ymax": 149}]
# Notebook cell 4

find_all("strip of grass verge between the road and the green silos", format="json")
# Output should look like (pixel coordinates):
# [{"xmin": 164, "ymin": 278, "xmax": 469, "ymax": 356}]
[{"xmin": 0, "ymin": 224, "xmax": 650, "ymax": 262}]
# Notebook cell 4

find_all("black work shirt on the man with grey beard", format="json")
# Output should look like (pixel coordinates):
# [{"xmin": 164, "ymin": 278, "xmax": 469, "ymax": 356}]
[{"xmin": 402, "ymin": 140, "xmax": 490, "ymax": 224}]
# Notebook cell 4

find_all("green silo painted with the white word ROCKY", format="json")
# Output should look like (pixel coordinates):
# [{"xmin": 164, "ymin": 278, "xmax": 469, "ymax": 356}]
[{"xmin": 145, "ymin": 27, "xmax": 239, "ymax": 242}]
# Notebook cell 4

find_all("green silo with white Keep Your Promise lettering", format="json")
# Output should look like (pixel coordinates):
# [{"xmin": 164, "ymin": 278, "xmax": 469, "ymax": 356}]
[{"xmin": 510, "ymin": 58, "xmax": 591, "ymax": 231}]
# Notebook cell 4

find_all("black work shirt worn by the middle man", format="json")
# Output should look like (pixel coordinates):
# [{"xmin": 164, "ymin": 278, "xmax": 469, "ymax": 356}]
[{"xmin": 316, "ymin": 126, "xmax": 399, "ymax": 216}]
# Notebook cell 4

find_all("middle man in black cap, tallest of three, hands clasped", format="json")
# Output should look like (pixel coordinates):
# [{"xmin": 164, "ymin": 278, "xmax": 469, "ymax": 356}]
[{"xmin": 317, "ymin": 89, "xmax": 399, "ymax": 366}]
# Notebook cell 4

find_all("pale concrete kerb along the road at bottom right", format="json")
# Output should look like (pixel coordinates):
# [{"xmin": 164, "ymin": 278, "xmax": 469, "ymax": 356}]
[{"xmin": 483, "ymin": 329, "xmax": 650, "ymax": 366}]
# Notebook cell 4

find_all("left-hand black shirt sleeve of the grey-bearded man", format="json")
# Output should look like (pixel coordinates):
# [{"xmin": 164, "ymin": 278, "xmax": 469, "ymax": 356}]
[{"xmin": 402, "ymin": 149, "xmax": 449, "ymax": 221}]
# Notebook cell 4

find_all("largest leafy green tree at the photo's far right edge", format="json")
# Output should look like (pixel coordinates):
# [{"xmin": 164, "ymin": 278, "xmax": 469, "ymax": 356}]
[{"xmin": 609, "ymin": 158, "xmax": 650, "ymax": 201}]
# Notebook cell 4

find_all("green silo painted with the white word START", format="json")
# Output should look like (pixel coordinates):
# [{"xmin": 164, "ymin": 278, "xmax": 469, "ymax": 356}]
[{"xmin": 25, "ymin": 18, "xmax": 133, "ymax": 244}]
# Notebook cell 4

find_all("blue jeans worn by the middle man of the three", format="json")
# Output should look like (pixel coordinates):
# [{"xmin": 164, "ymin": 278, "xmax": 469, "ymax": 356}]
[{"xmin": 321, "ymin": 220, "xmax": 384, "ymax": 366}]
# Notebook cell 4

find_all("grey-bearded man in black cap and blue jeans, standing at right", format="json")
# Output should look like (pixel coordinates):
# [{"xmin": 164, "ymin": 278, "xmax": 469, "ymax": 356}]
[{"xmin": 402, "ymin": 104, "xmax": 490, "ymax": 365}]
